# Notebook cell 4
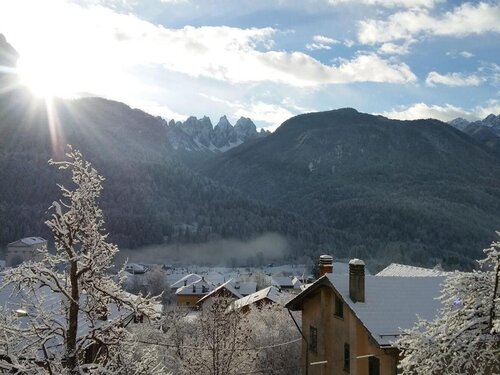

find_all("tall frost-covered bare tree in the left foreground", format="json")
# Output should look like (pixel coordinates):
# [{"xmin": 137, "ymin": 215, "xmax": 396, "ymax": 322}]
[{"xmin": 0, "ymin": 148, "xmax": 160, "ymax": 374}]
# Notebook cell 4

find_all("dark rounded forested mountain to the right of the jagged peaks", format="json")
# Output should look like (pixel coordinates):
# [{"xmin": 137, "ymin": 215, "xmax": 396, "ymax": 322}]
[{"xmin": 201, "ymin": 109, "xmax": 500, "ymax": 267}]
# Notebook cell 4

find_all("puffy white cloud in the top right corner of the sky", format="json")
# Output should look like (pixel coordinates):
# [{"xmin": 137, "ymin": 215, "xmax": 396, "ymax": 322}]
[{"xmin": 358, "ymin": 2, "xmax": 500, "ymax": 44}]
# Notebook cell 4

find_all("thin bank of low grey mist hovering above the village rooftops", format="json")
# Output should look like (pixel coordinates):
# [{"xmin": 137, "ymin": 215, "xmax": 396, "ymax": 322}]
[{"xmin": 115, "ymin": 233, "xmax": 290, "ymax": 267}]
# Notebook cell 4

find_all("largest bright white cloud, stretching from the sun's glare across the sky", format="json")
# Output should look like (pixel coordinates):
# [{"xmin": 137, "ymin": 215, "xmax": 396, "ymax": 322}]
[{"xmin": 0, "ymin": 0, "xmax": 416, "ymax": 101}]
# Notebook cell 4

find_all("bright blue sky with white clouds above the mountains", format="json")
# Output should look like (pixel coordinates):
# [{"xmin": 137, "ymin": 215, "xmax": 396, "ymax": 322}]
[{"xmin": 0, "ymin": 0, "xmax": 500, "ymax": 130}]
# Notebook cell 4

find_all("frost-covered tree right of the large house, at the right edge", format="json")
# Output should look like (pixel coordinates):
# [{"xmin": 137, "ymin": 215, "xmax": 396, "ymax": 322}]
[{"xmin": 397, "ymin": 232, "xmax": 500, "ymax": 375}]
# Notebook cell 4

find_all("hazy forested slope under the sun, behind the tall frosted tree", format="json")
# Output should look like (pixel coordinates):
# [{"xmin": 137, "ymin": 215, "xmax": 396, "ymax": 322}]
[{"xmin": 0, "ymin": 90, "xmax": 334, "ymax": 256}]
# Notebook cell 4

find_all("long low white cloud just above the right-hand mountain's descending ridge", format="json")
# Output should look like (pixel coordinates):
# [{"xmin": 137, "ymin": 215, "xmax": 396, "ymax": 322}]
[{"xmin": 381, "ymin": 99, "xmax": 500, "ymax": 122}]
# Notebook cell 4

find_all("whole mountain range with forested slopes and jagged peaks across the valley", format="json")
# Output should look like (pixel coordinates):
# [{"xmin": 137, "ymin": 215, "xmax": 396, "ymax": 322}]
[{"xmin": 0, "ymin": 34, "xmax": 500, "ymax": 269}]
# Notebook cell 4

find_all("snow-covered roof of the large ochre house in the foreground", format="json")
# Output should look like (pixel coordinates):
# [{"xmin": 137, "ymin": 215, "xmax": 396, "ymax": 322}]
[{"xmin": 328, "ymin": 274, "xmax": 446, "ymax": 346}]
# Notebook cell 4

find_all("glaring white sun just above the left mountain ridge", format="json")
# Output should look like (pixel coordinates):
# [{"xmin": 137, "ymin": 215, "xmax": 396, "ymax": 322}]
[{"xmin": 17, "ymin": 59, "xmax": 74, "ymax": 99}]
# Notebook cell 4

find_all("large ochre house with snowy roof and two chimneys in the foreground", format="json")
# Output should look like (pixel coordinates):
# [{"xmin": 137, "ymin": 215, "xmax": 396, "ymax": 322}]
[{"xmin": 285, "ymin": 256, "xmax": 445, "ymax": 375}]
